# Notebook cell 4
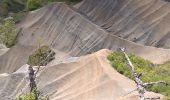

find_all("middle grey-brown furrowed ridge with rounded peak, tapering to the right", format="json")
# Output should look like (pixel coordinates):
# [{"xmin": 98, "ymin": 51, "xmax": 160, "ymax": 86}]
[{"xmin": 0, "ymin": 3, "xmax": 170, "ymax": 73}]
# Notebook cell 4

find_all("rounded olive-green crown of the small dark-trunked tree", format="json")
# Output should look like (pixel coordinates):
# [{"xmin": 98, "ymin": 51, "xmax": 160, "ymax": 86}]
[{"xmin": 27, "ymin": 46, "xmax": 55, "ymax": 66}]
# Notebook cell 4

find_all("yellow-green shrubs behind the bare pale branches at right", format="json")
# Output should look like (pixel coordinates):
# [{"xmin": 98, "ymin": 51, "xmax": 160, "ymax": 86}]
[{"xmin": 108, "ymin": 52, "xmax": 170, "ymax": 98}]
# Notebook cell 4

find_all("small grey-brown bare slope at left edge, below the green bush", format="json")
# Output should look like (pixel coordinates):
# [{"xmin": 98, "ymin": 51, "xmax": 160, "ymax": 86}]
[{"xmin": 0, "ymin": 45, "xmax": 34, "ymax": 73}]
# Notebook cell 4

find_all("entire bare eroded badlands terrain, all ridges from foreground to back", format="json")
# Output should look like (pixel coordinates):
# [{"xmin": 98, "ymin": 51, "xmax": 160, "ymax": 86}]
[{"xmin": 0, "ymin": 0, "xmax": 170, "ymax": 100}]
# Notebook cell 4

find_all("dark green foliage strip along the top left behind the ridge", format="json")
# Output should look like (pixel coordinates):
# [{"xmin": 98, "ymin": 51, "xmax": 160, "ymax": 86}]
[{"xmin": 0, "ymin": 0, "xmax": 82, "ymax": 17}]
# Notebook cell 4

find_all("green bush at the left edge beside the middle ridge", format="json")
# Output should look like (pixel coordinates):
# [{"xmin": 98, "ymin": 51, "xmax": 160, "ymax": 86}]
[{"xmin": 0, "ymin": 19, "xmax": 18, "ymax": 47}]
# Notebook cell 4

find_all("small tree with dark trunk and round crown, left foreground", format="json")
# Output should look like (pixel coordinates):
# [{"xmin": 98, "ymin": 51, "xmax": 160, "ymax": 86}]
[{"xmin": 18, "ymin": 45, "xmax": 55, "ymax": 100}]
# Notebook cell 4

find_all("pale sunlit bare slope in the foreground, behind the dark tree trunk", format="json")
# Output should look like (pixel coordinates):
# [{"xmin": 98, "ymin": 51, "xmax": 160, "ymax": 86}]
[{"xmin": 0, "ymin": 50, "xmax": 162, "ymax": 100}]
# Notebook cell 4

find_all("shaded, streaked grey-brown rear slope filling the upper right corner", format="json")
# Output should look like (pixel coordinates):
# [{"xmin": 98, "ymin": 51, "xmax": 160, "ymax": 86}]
[{"xmin": 76, "ymin": 0, "xmax": 170, "ymax": 48}]
